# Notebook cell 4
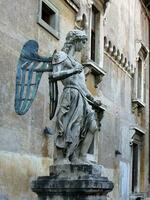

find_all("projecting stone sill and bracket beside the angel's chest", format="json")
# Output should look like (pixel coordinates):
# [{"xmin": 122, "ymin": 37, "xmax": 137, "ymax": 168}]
[{"xmin": 83, "ymin": 60, "xmax": 106, "ymax": 87}]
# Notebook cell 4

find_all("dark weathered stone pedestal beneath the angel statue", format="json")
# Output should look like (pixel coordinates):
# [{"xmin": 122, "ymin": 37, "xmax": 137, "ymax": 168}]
[{"xmin": 32, "ymin": 165, "xmax": 113, "ymax": 200}]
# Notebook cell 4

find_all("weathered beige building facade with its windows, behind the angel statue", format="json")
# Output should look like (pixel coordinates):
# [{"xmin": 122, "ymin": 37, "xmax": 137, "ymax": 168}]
[{"xmin": 0, "ymin": 0, "xmax": 150, "ymax": 200}]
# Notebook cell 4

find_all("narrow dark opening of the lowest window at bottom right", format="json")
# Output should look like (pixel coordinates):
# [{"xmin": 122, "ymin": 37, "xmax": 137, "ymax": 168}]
[{"xmin": 132, "ymin": 143, "xmax": 138, "ymax": 192}]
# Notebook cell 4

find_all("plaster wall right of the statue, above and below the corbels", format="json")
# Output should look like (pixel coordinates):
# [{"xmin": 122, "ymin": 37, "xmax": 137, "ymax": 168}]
[{"xmin": 98, "ymin": 0, "xmax": 149, "ymax": 200}]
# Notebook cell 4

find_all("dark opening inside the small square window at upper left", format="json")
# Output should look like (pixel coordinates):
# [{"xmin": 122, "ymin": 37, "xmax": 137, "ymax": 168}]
[{"xmin": 42, "ymin": 2, "xmax": 56, "ymax": 29}]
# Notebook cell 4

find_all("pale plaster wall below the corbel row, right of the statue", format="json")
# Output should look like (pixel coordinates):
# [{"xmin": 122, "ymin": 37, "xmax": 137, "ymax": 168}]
[{"xmin": 99, "ymin": 55, "xmax": 135, "ymax": 200}]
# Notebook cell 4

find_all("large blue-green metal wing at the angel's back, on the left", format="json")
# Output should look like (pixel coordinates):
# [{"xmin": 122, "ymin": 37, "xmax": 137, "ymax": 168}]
[{"xmin": 15, "ymin": 40, "xmax": 49, "ymax": 115}]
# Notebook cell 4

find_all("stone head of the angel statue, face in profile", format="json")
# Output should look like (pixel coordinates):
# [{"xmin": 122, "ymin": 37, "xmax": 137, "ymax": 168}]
[{"xmin": 63, "ymin": 29, "xmax": 87, "ymax": 53}]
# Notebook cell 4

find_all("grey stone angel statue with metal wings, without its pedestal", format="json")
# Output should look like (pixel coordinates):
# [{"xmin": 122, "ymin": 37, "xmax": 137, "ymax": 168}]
[{"xmin": 15, "ymin": 29, "xmax": 101, "ymax": 164}]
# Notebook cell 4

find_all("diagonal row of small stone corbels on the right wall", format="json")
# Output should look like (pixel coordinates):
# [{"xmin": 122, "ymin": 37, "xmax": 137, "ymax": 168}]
[{"xmin": 104, "ymin": 36, "xmax": 134, "ymax": 75}]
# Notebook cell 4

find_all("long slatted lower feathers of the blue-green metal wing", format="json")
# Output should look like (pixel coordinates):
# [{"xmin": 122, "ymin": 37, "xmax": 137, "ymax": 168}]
[{"xmin": 15, "ymin": 62, "xmax": 43, "ymax": 115}]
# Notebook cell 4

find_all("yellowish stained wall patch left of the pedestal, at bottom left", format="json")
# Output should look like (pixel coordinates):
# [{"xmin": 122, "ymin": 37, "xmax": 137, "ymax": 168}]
[{"xmin": 0, "ymin": 151, "xmax": 52, "ymax": 200}]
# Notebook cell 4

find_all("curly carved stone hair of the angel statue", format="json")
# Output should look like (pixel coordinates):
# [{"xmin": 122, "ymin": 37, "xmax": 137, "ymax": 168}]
[{"xmin": 62, "ymin": 29, "xmax": 87, "ymax": 52}]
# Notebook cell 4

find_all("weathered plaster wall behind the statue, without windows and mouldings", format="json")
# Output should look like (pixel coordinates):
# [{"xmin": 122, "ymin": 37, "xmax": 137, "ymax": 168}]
[{"xmin": 0, "ymin": 0, "xmax": 149, "ymax": 200}]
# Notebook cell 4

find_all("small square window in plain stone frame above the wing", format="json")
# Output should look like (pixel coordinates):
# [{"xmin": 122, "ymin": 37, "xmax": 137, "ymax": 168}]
[{"xmin": 38, "ymin": 0, "xmax": 59, "ymax": 39}]
